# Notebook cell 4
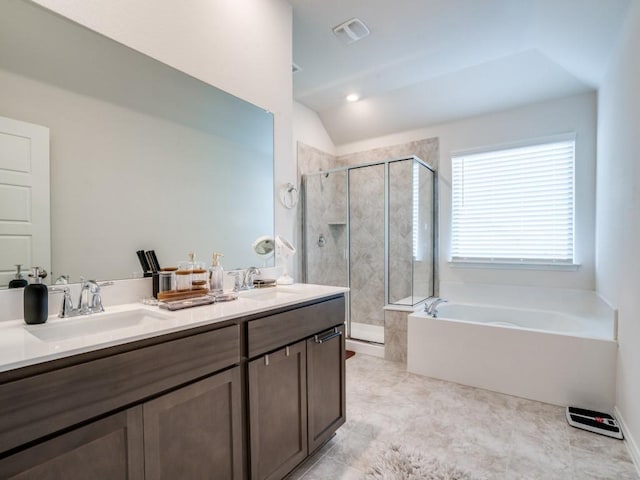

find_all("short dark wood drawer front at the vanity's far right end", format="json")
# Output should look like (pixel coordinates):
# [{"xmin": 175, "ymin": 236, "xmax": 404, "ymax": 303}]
[{"xmin": 247, "ymin": 296, "xmax": 345, "ymax": 358}]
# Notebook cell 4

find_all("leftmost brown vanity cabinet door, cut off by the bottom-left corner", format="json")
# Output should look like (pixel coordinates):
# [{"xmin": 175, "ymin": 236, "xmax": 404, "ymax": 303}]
[{"xmin": 0, "ymin": 407, "xmax": 144, "ymax": 480}]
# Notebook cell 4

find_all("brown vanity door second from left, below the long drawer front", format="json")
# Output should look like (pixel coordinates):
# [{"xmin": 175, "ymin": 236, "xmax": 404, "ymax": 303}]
[{"xmin": 143, "ymin": 367, "xmax": 242, "ymax": 480}]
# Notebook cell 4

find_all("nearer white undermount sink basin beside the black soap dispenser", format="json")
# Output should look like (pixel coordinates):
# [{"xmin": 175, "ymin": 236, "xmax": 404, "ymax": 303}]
[{"xmin": 25, "ymin": 309, "xmax": 171, "ymax": 342}]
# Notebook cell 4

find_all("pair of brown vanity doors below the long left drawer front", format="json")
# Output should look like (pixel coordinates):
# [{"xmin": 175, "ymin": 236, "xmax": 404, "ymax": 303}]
[{"xmin": 0, "ymin": 367, "xmax": 243, "ymax": 480}]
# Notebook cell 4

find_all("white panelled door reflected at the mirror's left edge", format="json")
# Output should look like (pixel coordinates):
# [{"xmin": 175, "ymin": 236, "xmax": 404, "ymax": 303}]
[{"xmin": 0, "ymin": 117, "xmax": 51, "ymax": 288}]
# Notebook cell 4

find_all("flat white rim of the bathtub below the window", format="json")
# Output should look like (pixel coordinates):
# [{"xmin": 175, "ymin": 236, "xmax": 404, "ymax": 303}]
[{"xmin": 410, "ymin": 301, "xmax": 617, "ymax": 343}]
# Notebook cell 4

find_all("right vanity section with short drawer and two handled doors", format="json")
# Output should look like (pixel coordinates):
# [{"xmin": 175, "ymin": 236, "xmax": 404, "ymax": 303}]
[{"xmin": 247, "ymin": 297, "xmax": 346, "ymax": 480}]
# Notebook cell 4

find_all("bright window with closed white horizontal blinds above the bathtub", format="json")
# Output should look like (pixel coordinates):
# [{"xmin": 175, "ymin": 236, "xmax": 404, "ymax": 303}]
[{"xmin": 451, "ymin": 137, "xmax": 575, "ymax": 265}]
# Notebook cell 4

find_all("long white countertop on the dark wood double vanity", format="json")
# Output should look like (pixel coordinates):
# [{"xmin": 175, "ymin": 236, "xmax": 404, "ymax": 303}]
[{"xmin": 0, "ymin": 284, "xmax": 348, "ymax": 372}]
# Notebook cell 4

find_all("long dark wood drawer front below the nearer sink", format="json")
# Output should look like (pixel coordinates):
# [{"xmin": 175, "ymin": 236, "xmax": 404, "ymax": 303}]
[{"xmin": 0, "ymin": 325, "xmax": 240, "ymax": 452}]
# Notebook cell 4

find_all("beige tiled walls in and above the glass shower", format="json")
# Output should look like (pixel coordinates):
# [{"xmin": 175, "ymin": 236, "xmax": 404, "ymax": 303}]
[{"xmin": 298, "ymin": 138, "xmax": 439, "ymax": 342}]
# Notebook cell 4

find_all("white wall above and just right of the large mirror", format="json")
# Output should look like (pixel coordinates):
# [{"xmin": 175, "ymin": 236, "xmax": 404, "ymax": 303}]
[{"xmin": 35, "ymin": 0, "xmax": 296, "ymax": 244}]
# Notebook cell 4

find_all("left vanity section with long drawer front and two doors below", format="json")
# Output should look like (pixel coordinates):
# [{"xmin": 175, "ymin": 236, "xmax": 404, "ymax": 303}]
[{"xmin": 0, "ymin": 324, "xmax": 243, "ymax": 480}]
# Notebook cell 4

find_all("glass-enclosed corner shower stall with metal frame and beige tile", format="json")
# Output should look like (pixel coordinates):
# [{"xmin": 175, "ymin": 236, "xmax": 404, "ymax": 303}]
[{"xmin": 303, "ymin": 156, "xmax": 437, "ymax": 344}]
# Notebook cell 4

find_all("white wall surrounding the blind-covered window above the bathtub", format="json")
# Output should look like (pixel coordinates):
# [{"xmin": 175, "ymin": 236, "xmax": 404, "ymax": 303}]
[{"xmin": 336, "ymin": 92, "xmax": 596, "ymax": 290}]
